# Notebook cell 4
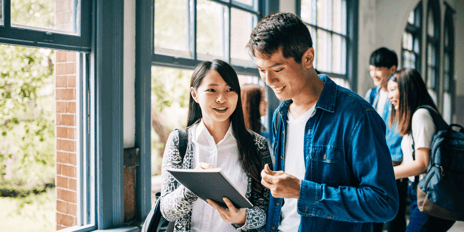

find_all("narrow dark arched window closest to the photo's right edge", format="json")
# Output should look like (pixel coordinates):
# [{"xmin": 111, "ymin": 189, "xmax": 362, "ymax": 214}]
[{"xmin": 443, "ymin": 6, "xmax": 455, "ymax": 123}]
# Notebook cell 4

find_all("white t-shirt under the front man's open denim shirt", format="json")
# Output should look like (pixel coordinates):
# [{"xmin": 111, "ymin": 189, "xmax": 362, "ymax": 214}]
[{"xmin": 279, "ymin": 104, "xmax": 316, "ymax": 232}]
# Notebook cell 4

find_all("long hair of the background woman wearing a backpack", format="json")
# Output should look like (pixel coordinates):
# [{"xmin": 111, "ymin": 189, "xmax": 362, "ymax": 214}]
[{"xmin": 388, "ymin": 69, "xmax": 438, "ymax": 136}]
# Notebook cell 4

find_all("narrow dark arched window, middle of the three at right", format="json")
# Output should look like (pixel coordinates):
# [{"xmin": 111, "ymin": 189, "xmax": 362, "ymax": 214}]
[{"xmin": 425, "ymin": 1, "xmax": 440, "ymax": 104}]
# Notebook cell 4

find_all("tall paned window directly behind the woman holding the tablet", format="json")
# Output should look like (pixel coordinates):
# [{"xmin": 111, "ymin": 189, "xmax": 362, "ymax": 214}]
[{"xmin": 151, "ymin": 0, "xmax": 261, "ymax": 179}]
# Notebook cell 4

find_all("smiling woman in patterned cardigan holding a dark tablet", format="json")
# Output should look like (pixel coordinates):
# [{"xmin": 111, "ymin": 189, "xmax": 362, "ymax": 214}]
[{"xmin": 161, "ymin": 60, "xmax": 271, "ymax": 232}]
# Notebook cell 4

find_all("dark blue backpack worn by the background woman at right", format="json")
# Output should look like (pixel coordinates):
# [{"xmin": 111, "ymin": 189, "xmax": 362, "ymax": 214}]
[{"xmin": 411, "ymin": 106, "xmax": 464, "ymax": 221}]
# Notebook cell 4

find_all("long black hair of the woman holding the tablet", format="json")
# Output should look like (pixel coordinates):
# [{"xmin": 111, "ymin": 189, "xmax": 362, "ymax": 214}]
[{"xmin": 187, "ymin": 60, "xmax": 263, "ymax": 193}]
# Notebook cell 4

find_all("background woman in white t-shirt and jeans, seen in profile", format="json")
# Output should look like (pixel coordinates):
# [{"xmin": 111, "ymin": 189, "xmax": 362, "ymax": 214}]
[{"xmin": 388, "ymin": 69, "xmax": 454, "ymax": 232}]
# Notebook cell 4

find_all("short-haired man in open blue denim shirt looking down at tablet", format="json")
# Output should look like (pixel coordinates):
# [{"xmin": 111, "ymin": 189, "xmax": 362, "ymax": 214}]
[{"xmin": 247, "ymin": 13, "xmax": 398, "ymax": 232}]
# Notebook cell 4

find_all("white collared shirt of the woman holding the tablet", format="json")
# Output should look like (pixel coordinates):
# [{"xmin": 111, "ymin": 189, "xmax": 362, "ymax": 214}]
[{"xmin": 191, "ymin": 121, "xmax": 248, "ymax": 232}]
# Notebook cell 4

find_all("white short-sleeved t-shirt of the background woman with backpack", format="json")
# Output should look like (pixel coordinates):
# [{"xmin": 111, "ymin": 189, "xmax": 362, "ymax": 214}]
[{"xmin": 401, "ymin": 109, "xmax": 436, "ymax": 181}]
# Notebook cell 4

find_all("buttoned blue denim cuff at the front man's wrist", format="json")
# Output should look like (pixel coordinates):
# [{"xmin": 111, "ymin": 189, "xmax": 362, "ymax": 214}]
[{"xmin": 297, "ymin": 180, "xmax": 322, "ymax": 214}]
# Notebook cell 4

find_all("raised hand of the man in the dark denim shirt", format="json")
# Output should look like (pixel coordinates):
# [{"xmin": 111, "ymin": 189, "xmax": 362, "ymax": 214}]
[{"xmin": 261, "ymin": 164, "xmax": 301, "ymax": 198}]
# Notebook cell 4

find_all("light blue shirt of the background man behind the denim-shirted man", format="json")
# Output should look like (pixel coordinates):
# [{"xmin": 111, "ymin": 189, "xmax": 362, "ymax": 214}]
[{"xmin": 364, "ymin": 86, "xmax": 403, "ymax": 162}]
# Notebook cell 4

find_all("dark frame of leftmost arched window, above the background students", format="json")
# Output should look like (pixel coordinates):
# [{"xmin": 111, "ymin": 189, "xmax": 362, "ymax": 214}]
[{"xmin": 401, "ymin": 1, "xmax": 422, "ymax": 70}]
